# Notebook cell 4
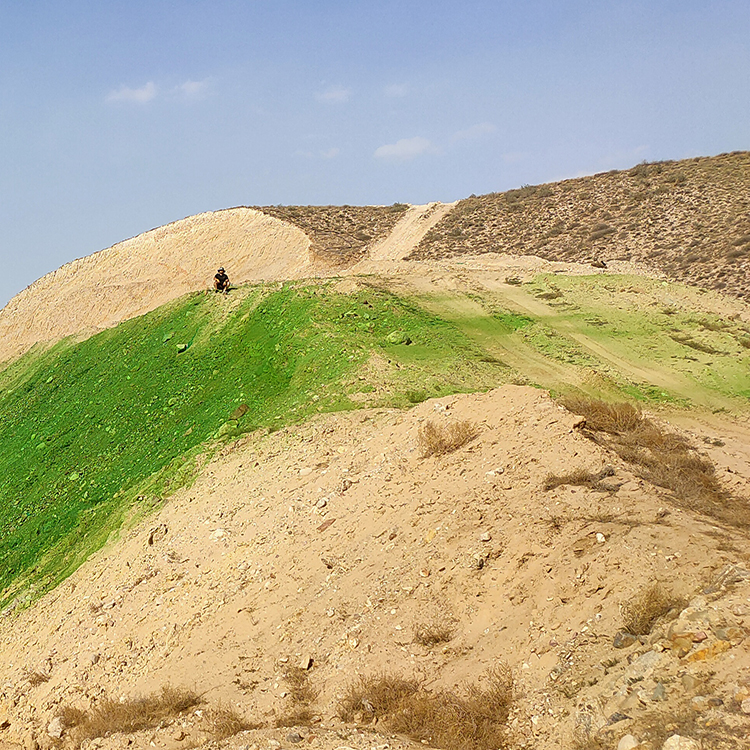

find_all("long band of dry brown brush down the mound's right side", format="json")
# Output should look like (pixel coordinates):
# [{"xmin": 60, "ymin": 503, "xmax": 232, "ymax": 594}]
[{"xmin": 563, "ymin": 397, "xmax": 750, "ymax": 528}]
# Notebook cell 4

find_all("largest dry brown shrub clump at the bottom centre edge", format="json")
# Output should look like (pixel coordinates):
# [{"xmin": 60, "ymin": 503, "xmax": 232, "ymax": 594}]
[{"xmin": 341, "ymin": 666, "xmax": 513, "ymax": 750}]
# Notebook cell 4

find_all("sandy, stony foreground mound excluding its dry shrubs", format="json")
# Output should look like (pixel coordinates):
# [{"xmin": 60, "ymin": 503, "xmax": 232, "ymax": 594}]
[{"xmin": 0, "ymin": 386, "xmax": 750, "ymax": 750}]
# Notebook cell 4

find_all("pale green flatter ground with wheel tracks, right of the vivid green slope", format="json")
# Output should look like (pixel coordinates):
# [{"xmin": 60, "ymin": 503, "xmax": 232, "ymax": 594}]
[{"xmin": 412, "ymin": 274, "xmax": 750, "ymax": 412}]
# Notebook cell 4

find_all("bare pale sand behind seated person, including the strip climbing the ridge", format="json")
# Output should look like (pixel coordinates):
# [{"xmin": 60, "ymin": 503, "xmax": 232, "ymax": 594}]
[{"xmin": 0, "ymin": 203, "xmax": 668, "ymax": 372}]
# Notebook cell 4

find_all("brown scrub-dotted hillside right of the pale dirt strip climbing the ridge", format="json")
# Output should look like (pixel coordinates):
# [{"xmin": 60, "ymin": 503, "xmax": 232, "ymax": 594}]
[{"xmin": 411, "ymin": 151, "xmax": 750, "ymax": 299}]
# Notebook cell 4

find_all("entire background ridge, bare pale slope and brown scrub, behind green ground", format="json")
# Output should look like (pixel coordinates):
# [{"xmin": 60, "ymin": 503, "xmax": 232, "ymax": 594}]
[{"xmin": 0, "ymin": 152, "xmax": 750, "ymax": 363}]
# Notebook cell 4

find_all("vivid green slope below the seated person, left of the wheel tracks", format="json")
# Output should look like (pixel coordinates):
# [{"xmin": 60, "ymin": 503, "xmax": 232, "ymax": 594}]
[{"xmin": 0, "ymin": 284, "xmax": 504, "ymax": 605}]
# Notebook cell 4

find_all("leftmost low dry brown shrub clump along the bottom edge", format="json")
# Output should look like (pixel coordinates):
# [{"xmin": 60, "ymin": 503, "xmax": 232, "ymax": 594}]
[{"xmin": 60, "ymin": 685, "xmax": 203, "ymax": 743}]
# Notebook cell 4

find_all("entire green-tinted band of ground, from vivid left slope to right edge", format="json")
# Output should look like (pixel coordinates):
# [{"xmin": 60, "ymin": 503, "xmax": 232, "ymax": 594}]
[{"xmin": 5, "ymin": 274, "xmax": 750, "ymax": 607}]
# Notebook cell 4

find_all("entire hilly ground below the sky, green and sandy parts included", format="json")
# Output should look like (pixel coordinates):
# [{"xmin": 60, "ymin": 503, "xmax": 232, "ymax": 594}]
[{"xmin": 0, "ymin": 153, "xmax": 750, "ymax": 750}]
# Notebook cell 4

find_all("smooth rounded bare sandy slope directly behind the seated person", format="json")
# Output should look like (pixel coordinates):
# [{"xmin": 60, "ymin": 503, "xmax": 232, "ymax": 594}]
[{"xmin": 0, "ymin": 208, "xmax": 314, "ymax": 362}]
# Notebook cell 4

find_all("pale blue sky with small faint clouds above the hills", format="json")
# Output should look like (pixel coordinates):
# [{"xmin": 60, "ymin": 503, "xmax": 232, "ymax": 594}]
[{"xmin": 0, "ymin": 0, "xmax": 750, "ymax": 306}]
